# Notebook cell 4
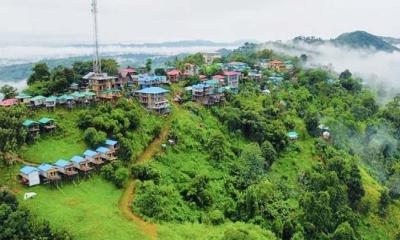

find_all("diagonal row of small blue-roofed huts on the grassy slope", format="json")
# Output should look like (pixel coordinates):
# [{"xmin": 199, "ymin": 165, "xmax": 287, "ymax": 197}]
[{"xmin": 19, "ymin": 139, "xmax": 119, "ymax": 186}]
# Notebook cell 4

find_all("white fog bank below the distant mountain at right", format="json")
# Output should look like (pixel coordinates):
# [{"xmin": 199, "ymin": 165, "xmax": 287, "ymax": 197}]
[{"xmin": 265, "ymin": 43, "xmax": 400, "ymax": 101}]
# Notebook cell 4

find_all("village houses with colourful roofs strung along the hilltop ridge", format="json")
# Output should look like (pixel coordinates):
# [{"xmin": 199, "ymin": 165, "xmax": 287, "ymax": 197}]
[{"xmin": 0, "ymin": 57, "xmax": 294, "ymax": 113}]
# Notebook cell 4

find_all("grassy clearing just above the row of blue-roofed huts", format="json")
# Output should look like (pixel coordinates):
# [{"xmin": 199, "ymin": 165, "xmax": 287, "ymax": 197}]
[{"xmin": 20, "ymin": 108, "xmax": 86, "ymax": 163}]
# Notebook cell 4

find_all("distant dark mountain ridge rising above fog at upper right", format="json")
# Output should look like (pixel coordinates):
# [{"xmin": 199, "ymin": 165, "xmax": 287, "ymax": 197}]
[{"xmin": 293, "ymin": 31, "xmax": 400, "ymax": 52}]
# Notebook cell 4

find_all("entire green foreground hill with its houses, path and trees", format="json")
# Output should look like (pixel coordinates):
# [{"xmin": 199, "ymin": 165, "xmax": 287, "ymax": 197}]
[{"xmin": 0, "ymin": 43, "xmax": 400, "ymax": 240}]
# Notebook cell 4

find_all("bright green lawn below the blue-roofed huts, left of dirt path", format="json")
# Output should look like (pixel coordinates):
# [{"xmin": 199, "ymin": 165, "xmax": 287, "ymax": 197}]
[{"xmin": 19, "ymin": 177, "xmax": 147, "ymax": 240}]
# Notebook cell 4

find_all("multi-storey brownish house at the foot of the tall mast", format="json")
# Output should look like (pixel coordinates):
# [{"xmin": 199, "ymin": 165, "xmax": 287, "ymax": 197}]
[{"xmin": 89, "ymin": 73, "xmax": 122, "ymax": 100}]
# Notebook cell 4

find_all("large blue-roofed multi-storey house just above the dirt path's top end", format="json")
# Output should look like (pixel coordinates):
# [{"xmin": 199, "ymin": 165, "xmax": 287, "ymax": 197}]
[{"xmin": 135, "ymin": 87, "xmax": 170, "ymax": 113}]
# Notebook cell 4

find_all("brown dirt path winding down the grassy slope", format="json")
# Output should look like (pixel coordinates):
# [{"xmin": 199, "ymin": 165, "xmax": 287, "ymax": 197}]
[{"xmin": 119, "ymin": 122, "xmax": 169, "ymax": 240}]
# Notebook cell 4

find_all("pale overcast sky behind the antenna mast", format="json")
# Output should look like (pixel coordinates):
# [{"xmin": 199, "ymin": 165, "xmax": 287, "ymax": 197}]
[{"xmin": 0, "ymin": 0, "xmax": 400, "ymax": 44}]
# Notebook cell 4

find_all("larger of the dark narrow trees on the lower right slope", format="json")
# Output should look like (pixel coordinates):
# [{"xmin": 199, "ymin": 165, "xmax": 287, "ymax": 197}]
[{"xmin": 347, "ymin": 164, "xmax": 365, "ymax": 209}]
